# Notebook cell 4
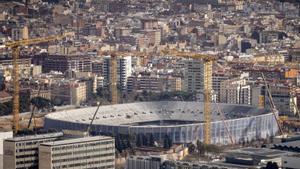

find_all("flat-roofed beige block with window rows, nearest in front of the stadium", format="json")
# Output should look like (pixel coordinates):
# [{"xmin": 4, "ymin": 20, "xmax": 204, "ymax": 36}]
[{"xmin": 39, "ymin": 136, "xmax": 115, "ymax": 169}]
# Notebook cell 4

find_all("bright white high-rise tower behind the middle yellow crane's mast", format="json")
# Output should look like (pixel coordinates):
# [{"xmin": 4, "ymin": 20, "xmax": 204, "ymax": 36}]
[{"xmin": 103, "ymin": 56, "xmax": 132, "ymax": 90}]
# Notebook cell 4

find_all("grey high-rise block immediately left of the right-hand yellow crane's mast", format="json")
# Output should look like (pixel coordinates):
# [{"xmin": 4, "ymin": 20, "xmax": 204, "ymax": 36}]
[{"xmin": 183, "ymin": 60, "xmax": 204, "ymax": 92}]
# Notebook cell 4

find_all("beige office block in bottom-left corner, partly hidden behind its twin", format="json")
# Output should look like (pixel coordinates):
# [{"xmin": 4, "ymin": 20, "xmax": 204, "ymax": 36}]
[{"xmin": 3, "ymin": 133, "xmax": 63, "ymax": 169}]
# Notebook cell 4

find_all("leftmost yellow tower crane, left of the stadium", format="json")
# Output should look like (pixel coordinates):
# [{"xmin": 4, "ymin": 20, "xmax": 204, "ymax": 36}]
[{"xmin": 2, "ymin": 35, "xmax": 65, "ymax": 134}]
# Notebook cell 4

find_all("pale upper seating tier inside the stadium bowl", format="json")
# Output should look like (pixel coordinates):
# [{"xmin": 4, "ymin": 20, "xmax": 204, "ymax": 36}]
[{"xmin": 47, "ymin": 101, "xmax": 270, "ymax": 126}]
